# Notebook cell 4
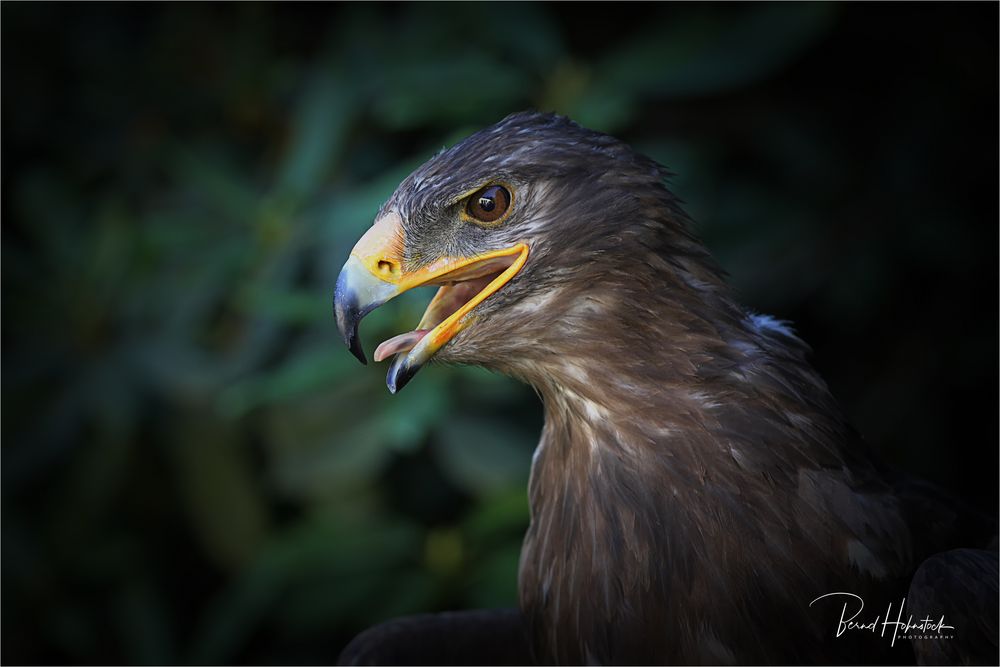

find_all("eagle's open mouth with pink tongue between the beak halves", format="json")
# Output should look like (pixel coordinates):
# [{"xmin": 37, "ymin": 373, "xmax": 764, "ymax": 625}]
[{"xmin": 374, "ymin": 246, "xmax": 525, "ymax": 361}]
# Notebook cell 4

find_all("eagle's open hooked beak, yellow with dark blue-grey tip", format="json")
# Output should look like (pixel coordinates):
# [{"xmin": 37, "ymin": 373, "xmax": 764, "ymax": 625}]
[{"xmin": 333, "ymin": 211, "xmax": 528, "ymax": 393}]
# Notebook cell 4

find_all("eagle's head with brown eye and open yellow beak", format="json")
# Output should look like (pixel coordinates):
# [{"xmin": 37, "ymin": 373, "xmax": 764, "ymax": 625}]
[{"xmin": 334, "ymin": 112, "xmax": 715, "ymax": 393}]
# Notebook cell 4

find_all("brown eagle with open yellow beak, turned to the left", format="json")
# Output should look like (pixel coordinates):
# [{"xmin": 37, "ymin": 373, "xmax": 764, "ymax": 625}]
[{"xmin": 334, "ymin": 112, "xmax": 998, "ymax": 664}]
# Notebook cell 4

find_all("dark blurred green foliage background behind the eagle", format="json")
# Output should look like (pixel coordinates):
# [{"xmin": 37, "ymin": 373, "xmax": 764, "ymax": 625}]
[{"xmin": 0, "ymin": 3, "xmax": 998, "ymax": 664}]
